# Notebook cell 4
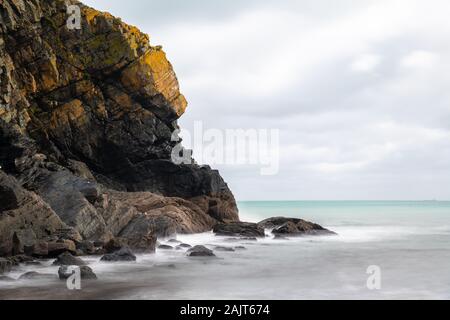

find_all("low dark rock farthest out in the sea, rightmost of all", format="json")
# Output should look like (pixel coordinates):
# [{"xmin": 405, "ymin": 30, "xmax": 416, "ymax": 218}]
[{"xmin": 258, "ymin": 217, "xmax": 336, "ymax": 236}]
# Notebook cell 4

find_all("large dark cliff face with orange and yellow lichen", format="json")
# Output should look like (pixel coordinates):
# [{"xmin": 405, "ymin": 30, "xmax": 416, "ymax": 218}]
[{"xmin": 0, "ymin": 0, "xmax": 238, "ymax": 255}]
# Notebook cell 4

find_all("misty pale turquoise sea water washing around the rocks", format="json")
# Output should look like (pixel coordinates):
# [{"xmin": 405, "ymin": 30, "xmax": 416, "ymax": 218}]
[{"xmin": 0, "ymin": 201, "xmax": 450, "ymax": 299}]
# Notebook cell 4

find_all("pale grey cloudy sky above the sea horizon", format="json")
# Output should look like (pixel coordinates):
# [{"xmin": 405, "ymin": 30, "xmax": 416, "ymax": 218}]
[{"xmin": 84, "ymin": 0, "xmax": 450, "ymax": 200}]
